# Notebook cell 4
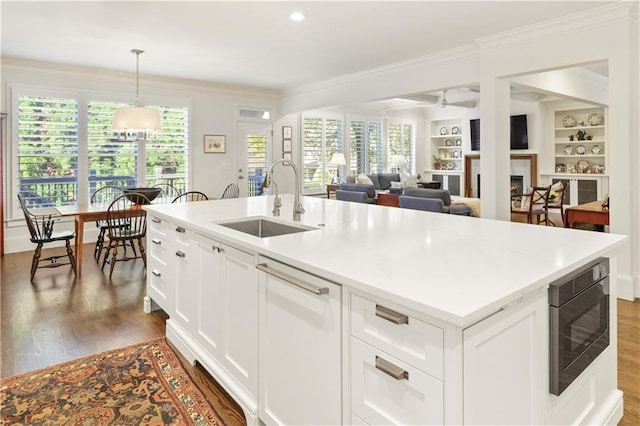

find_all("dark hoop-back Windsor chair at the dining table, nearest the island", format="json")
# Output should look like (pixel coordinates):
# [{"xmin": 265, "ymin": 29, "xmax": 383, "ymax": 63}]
[{"xmin": 102, "ymin": 194, "xmax": 149, "ymax": 279}]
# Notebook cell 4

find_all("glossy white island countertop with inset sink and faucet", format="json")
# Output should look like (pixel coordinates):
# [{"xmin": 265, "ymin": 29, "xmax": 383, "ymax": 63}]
[{"xmin": 145, "ymin": 195, "xmax": 626, "ymax": 327}]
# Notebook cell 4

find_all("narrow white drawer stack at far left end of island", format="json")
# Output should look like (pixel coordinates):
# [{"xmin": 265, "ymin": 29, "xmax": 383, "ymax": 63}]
[{"xmin": 144, "ymin": 215, "xmax": 175, "ymax": 316}]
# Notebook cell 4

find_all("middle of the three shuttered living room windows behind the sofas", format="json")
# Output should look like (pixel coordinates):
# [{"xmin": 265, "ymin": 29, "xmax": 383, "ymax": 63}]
[{"xmin": 349, "ymin": 120, "xmax": 382, "ymax": 174}]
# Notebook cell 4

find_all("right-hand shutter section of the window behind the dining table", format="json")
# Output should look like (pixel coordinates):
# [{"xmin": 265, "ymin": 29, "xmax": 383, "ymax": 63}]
[{"xmin": 145, "ymin": 105, "xmax": 190, "ymax": 192}]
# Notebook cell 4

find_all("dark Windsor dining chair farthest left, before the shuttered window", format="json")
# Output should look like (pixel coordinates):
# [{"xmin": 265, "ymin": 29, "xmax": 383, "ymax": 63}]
[{"xmin": 18, "ymin": 194, "xmax": 77, "ymax": 282}]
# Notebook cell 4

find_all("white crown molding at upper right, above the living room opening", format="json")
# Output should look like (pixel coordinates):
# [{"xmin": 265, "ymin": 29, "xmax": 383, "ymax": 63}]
[{"xmin": 475, "ymin": 0, "xmax": 638, "ymax": 49}]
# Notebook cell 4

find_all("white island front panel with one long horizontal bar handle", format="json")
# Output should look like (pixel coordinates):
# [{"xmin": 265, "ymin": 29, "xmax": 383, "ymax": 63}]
[{"xmin": 259, "ymin": 257, "xmax": 342, "ymax": 425}]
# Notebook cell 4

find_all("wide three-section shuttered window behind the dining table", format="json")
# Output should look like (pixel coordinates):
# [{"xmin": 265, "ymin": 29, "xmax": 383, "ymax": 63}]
[{"xmin": 13, "ymin": 88, "xmax": 189, "ymax": 217}]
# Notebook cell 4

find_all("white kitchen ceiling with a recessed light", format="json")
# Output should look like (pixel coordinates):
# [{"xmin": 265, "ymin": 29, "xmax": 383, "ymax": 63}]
[{"xmin": 0, "ymin": 0, "xmax": 613, "ymax": 93}]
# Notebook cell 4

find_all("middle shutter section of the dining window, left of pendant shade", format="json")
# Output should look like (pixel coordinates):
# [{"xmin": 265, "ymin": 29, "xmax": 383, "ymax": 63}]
[{"xmin": 87, "ymin": 101, "xmax": 139, "ymax": 199}]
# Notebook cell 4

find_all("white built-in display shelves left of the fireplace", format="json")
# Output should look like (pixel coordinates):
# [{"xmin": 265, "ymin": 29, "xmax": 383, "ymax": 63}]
[{"xmin": 431, "ymin": 118, "xmax": 463, "ymax": 171}]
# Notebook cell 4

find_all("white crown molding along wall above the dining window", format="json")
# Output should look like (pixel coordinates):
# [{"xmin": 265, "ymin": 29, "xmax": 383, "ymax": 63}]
[{"xmin": 0, "ymin": 56, "xmax": 282, "ymax": 99}]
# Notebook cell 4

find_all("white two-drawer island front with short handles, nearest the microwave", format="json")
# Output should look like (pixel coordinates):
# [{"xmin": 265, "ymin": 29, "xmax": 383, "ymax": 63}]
[{"xmin": 349, "ymin": 294, "xmax": 445, "ymax": 424}]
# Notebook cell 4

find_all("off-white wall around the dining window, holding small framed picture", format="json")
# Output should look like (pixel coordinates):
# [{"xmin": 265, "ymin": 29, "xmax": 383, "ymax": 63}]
[{"xmin": 0, "ymin": 58, "xmax": 281, "ymax": 253}]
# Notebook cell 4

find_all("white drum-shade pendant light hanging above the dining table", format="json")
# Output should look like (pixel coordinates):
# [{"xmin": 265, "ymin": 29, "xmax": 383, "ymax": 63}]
[{"xmin": 111, "ymin": 49, "xmax": 162, "ymax": 139}]
